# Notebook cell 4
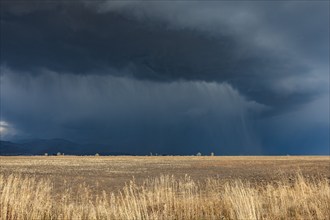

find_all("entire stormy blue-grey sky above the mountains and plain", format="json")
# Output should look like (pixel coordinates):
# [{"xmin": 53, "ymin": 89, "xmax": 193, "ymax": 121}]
[{"xmin": 0, "ymin": 0, "xmax": 330, "ymax": 155}]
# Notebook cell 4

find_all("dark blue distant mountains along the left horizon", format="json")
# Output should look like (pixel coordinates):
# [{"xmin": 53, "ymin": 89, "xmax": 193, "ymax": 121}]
[{"xmin": 0, "ymin": 139, "xmax": 129, "ymax": 156}]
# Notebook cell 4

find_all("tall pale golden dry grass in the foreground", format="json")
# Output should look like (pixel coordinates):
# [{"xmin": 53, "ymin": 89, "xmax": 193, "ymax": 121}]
[{"xmin": 0, "ymin": 173, "xmax": 330, "ymax": 220}]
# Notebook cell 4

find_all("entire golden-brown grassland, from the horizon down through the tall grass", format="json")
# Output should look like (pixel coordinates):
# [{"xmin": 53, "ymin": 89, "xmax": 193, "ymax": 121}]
[{"xmin": 0, "ymin": 156, "xmax": 330, "ymax": 220}]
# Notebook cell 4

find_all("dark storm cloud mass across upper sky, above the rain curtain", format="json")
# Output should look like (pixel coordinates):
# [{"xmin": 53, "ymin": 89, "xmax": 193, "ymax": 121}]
[{"xmin": 1, "ymin": 1, "xmax": 329, "ymax": 110}]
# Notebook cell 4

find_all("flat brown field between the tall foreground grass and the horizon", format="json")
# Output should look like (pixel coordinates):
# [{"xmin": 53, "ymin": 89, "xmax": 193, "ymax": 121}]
[{"xmin": 0, "ymin": 156, "xmax": 330, "ymax": 193}]
